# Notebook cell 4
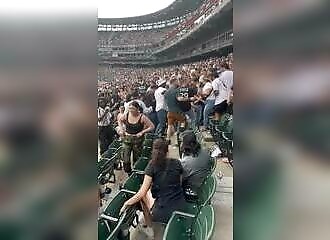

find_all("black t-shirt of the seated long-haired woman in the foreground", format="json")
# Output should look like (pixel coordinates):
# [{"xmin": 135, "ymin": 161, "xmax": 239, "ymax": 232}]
[{"xmin": 145, "ymin": 159, "xmax": 183, "ymax": 203}]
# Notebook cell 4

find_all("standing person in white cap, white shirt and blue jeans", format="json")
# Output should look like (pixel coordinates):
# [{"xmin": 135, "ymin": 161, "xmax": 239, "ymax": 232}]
[{"xmin": 155, "ymin": 79, "xmax": 167, "ymax": 137}]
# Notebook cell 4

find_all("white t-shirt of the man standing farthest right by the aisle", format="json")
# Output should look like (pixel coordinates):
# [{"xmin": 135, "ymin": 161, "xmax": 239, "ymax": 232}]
[{"xmin": 212, "ymin": 70, "xmax": 234, "ymax": 105}]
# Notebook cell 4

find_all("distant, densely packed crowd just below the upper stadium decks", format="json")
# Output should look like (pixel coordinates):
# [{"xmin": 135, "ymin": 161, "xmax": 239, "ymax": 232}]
[{"xmin": 98, "ymin": 54, "xmax": 233, "ymax": 126}]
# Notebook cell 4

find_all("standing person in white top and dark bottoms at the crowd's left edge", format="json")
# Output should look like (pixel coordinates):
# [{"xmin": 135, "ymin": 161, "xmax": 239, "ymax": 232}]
[{"xmin": 97, "ymin": 99, "xmax": 114, "ymax": 155}]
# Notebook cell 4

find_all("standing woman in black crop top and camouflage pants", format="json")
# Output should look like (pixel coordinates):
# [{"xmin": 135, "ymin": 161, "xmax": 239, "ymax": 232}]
[{"xmin": 118, "ymin": 101, "xmax": 155, "ymax": 174}]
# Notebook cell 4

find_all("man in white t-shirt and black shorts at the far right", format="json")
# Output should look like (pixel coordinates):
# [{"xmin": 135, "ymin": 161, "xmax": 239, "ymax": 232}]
[{"xmin": 213, "ymin": 63, "xmax": 234, "ymax": 120}]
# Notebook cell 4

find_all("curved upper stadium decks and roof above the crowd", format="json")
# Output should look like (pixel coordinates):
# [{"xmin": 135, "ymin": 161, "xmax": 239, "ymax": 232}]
[{"xmin": 98, "ymin": 0, "xmax": 234, "ymax": 79}]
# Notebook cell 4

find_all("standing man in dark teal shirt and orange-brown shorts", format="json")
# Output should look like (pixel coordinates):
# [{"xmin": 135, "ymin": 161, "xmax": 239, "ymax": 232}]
[{"xmin": 165, "ymin": 78, "xmax": 186, "ymax": 141}]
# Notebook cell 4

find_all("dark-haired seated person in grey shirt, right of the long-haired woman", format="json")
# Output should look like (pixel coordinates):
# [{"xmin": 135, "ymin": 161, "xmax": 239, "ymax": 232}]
[{"xmin": 181, "ymin": 130, "xmax": 213, "ymax": 191}]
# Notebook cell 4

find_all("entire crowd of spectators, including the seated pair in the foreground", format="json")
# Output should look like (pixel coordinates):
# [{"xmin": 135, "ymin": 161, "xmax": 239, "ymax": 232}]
[{"xmin": 98, "ymin": 54, "xmax": 233, "ymax": 236}]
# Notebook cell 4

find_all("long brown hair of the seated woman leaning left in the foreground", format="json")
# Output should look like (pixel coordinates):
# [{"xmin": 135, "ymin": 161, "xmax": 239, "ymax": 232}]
[{"xmin": 151, "ymin": 138, "xmax": 168, "ymax": 169}]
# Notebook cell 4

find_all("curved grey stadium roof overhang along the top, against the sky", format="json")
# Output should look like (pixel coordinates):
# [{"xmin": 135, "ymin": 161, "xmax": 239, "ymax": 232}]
[{"xmin": 98, "ymin": 0, "xmax": 203, "ymax": 24}]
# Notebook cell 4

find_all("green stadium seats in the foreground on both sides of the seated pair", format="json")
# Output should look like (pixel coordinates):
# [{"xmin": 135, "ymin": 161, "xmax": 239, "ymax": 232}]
[{"xmin": 98, "ymin": 130, "xmax": 217, "ymax": 240}]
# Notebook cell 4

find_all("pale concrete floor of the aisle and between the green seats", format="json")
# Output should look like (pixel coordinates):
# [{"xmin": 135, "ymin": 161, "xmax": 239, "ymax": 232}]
[{"xmin": 99, "ymin": 131, "xmax": 233, "ymax": 240}]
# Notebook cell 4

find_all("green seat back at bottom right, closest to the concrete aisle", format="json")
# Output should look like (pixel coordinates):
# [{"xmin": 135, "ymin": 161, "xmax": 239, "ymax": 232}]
[{"xmin": 192, "ymin": 205, "xmax": 215, "ymax": 240}]
